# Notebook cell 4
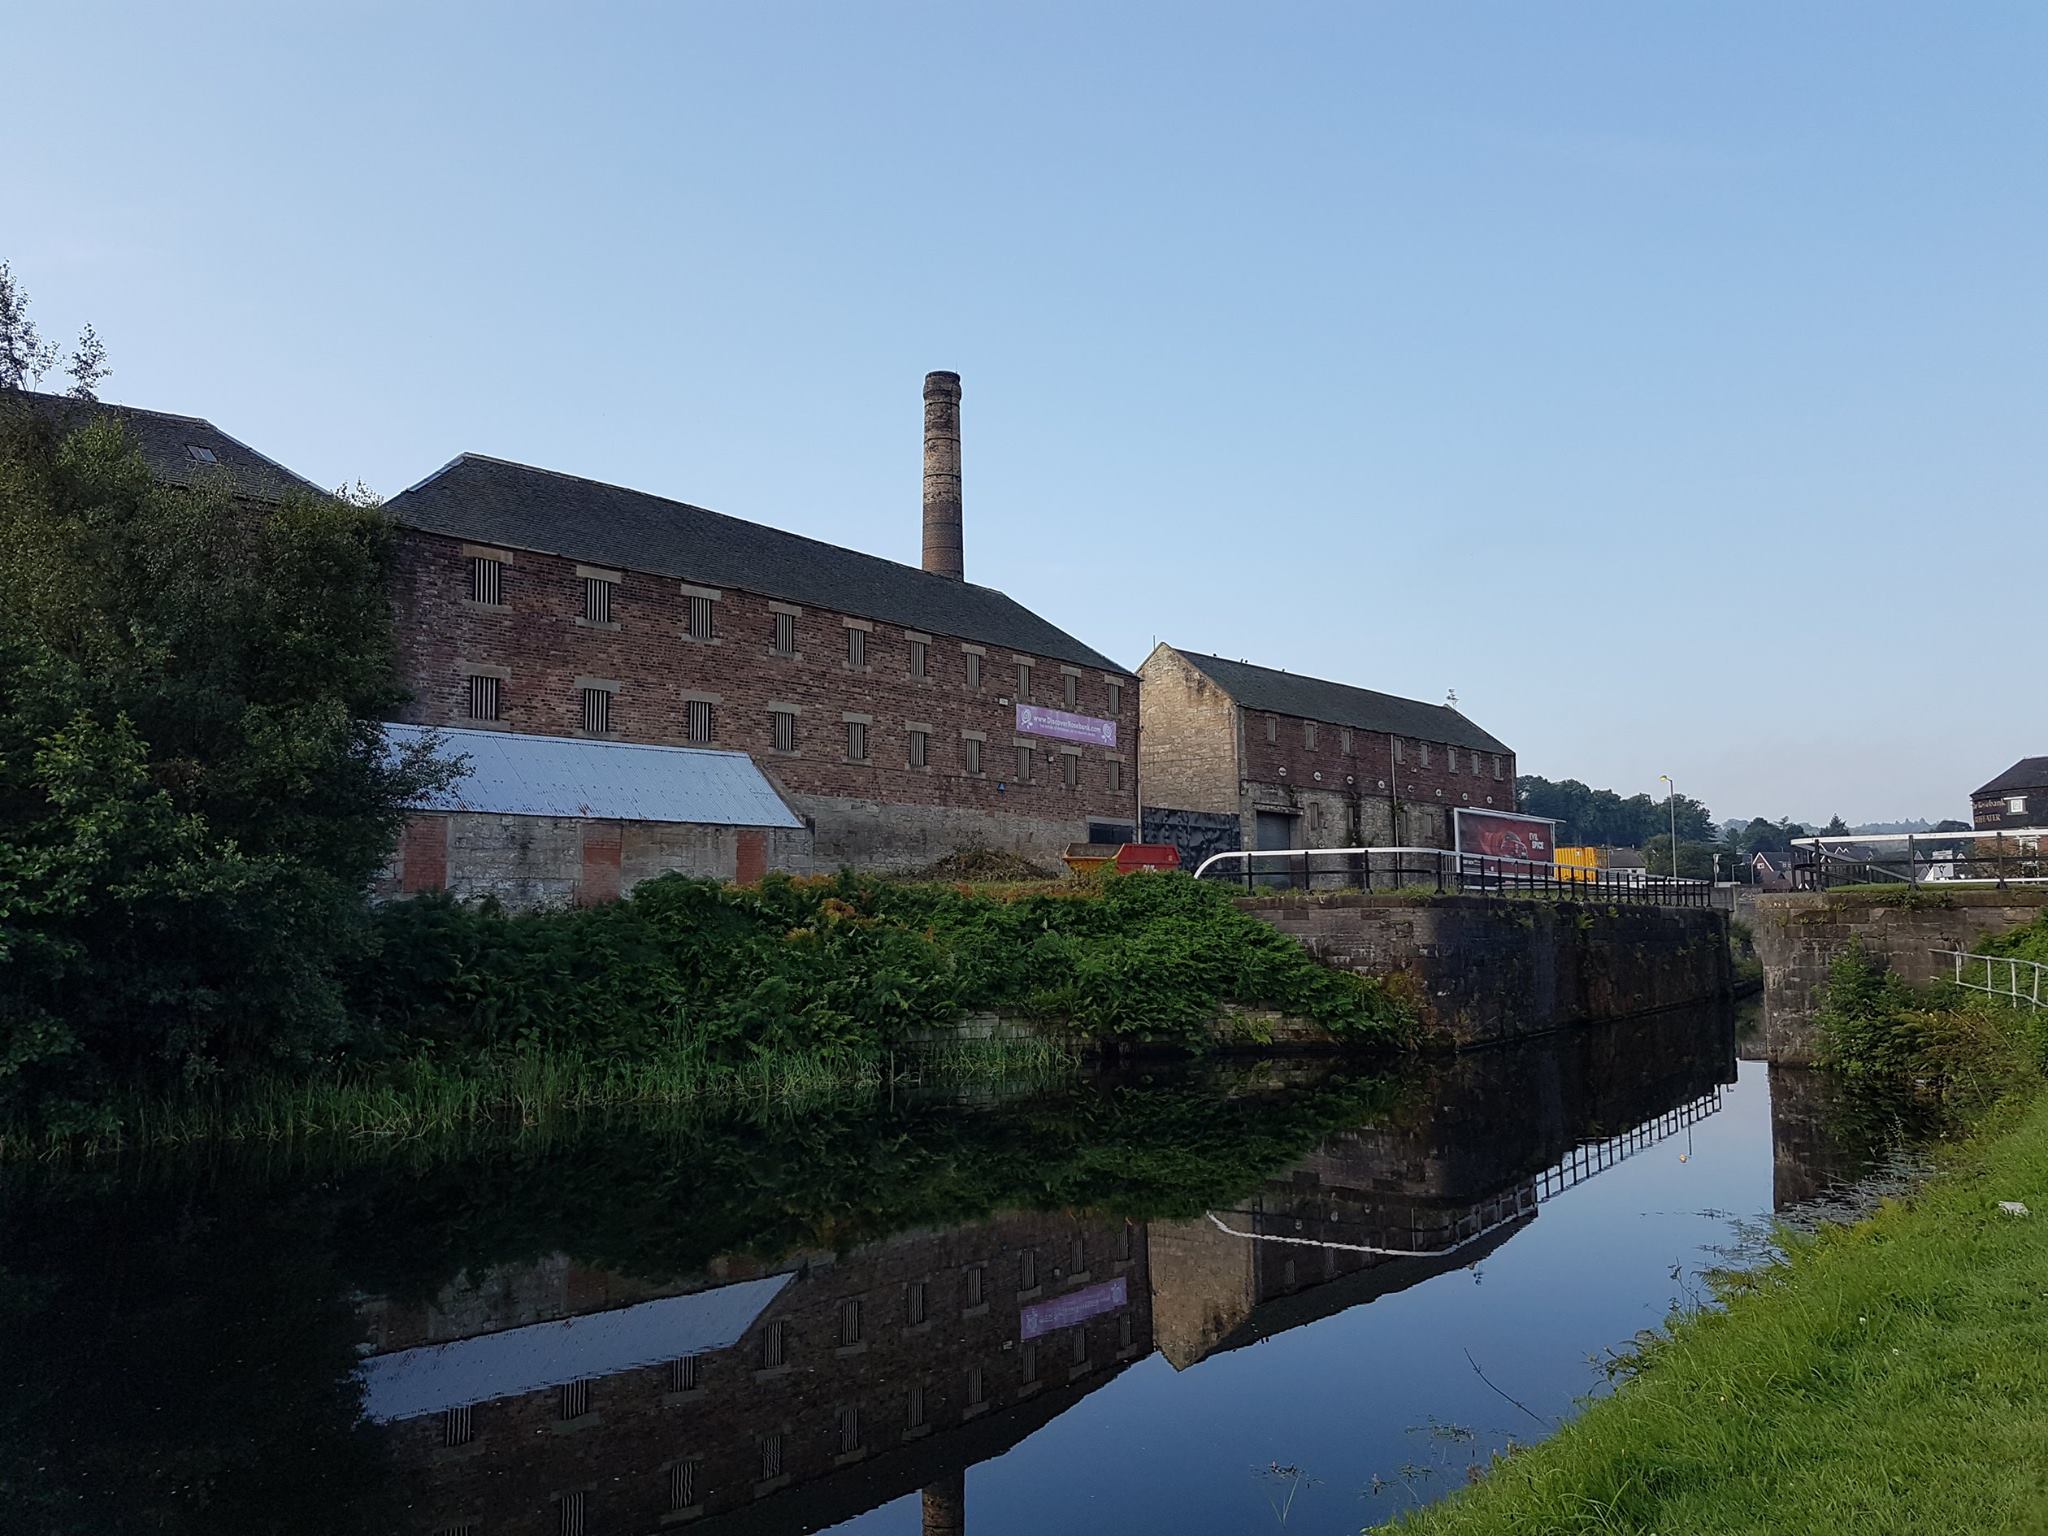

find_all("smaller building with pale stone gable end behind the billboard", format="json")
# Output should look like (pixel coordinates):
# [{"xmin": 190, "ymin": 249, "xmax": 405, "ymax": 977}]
[{"xmin": 1139, "ymin": 645, "xmax": 1516, "ymax": 860}]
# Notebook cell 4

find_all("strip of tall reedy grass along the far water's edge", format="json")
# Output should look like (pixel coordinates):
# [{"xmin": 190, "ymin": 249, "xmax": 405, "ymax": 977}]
[{"xmin": 0, "ymin": 1040, "xmax": 1079, "ymax": 1161}]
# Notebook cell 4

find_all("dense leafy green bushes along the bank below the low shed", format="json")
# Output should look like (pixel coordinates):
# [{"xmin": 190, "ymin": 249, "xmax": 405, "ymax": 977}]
[{"xmin": 356, "ymin": 872, "xmax": 1411, "ymax": 1057}]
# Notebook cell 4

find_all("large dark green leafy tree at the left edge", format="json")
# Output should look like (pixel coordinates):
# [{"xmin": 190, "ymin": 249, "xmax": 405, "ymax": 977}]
[{"xmin": 0, "ymin": 391, "xmax": 444, "ymax": 1124}]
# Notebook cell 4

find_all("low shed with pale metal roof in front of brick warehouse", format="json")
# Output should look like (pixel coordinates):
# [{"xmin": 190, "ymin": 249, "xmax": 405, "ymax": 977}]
[{"xmin": 375, "ymin": 725, "xmax": 811, "ymax": 907}]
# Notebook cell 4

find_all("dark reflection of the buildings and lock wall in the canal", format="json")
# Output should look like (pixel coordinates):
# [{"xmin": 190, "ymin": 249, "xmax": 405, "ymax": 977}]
[{"xmin": 360, "ymin": 1012, "xmax": 1735, "ymax": 1536}]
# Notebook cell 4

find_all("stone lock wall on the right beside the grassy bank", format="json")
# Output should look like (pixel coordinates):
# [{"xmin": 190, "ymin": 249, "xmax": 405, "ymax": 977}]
[{"xmin": 1749, "ymin": 885, "xmax": 2048, "ymax": 1065}]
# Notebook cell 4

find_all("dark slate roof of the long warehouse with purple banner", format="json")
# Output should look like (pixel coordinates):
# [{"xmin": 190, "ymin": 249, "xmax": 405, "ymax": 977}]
[{"xmin": 385, "ymin": 453, "xmax": 1128, "ymax": 676}]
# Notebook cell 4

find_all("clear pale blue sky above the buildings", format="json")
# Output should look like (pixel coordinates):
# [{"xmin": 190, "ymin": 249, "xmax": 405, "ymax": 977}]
[{"xmin": 0, "ymin": 0, "xmax": 2048, "ymax": 823}]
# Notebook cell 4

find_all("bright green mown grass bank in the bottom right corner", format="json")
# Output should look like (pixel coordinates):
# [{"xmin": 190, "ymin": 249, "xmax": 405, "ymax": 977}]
[{"xmin": 1393, "ymin": 1064, "xmax": 2048, "ymax": 1536}]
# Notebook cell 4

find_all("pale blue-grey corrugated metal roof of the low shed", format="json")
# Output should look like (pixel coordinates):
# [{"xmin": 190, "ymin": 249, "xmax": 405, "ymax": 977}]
[{"xmin": 385, "ymin": 725, "xmax": 803, "ymax": 827}]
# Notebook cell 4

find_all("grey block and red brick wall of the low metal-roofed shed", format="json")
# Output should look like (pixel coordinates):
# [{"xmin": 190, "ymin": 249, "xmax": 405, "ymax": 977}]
[{"xmin": 373, "ymin": 811, "xmax": 813, "ymax": 911}]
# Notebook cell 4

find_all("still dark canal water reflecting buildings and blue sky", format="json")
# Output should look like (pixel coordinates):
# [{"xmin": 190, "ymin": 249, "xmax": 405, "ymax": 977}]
[{"xmin": 0, "ymin": 1012, "xmax": 1868, "ymax": 1536}]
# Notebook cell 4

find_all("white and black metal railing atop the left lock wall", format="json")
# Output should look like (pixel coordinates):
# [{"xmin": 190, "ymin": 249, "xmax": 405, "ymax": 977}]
[{"xmin": 1194, "ymin": 848, "xmax": 1722, "ymax": 907}]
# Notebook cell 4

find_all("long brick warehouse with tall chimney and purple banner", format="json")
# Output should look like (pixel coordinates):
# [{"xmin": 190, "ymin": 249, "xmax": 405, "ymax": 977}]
[{"xmin": 387, "ymin": 373, "xmax": 1139, "ymax": 868}]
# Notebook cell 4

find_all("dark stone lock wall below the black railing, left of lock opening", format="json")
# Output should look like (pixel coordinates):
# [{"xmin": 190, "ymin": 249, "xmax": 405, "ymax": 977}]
[{"xmin": 1239, "ymin": 891, "xmax": 1733, "ymax": 1047}]
